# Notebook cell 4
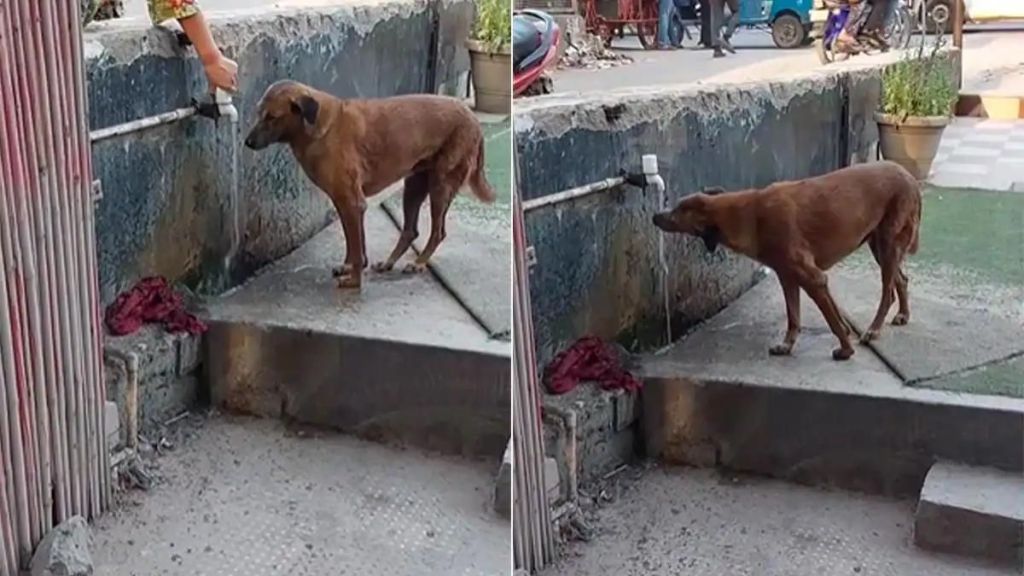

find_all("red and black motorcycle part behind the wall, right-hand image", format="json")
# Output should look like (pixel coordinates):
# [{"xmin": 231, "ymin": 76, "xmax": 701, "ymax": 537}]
[{"xmin": 512, "ymin": 10, "xmax": 561, "ymax": 96}]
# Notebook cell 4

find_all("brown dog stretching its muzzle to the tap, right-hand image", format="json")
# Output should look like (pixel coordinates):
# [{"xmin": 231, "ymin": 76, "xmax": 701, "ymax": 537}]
[{"xmin": 654, "ymin": 162, "xmax": 921, "ymax": 360}]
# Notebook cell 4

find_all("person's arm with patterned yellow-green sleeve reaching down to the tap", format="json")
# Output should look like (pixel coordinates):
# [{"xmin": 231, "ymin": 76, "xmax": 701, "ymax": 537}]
[{"xmin": 146, "ymin": 0, "xmax": 239, "ymax": 92}]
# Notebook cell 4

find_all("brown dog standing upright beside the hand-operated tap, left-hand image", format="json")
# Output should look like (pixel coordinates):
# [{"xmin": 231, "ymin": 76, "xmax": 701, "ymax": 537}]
[{"xmin": 246, "ymin": 80, "xmax": 495, "ymax": 288}]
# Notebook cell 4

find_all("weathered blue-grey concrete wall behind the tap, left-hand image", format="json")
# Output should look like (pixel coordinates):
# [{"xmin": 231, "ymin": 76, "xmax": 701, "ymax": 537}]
[{"xmin": 85, "ymin": 0, "xmax": 473, "ymax": 302}]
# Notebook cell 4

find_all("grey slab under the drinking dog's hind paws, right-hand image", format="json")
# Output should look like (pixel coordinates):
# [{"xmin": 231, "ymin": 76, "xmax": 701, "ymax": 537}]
[{"xmin": 831, "ymin": 274, "xmax": 1024, "ymax": 384}]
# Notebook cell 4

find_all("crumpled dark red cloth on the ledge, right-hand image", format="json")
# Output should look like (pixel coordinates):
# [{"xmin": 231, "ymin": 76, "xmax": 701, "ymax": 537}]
[{"xmin": 544, "ymin": 336, "xmax": 640, "ymax": 395}]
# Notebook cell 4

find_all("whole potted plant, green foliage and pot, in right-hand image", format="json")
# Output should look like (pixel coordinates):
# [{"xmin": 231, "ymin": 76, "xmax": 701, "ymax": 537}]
[{"xmin": 874, "ymin": 37, "xmax": 958, "ymax": 180}]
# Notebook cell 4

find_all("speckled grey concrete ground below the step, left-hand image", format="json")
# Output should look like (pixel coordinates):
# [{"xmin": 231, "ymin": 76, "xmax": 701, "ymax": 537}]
[{"xmin": 93, "ymin": 418, "xmax": 511, "ymax": 576}]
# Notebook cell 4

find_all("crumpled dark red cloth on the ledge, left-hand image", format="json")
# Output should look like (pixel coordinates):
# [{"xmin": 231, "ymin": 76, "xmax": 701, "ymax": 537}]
[{"xmin": 105, "ymin": 277, "xmax": 206, "ymax": 336}]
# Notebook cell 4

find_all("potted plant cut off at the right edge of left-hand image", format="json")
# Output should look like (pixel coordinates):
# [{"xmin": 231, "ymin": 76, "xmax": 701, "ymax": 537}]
[{"xmin": 466, "ymin": 0, "xmax": 512, "ymax": 114}]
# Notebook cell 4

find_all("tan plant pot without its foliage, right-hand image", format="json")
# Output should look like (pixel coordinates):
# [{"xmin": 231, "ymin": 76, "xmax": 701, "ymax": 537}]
[{"xmin": 874, "ymin": 113, "xmax": 949, "ymax": 180}]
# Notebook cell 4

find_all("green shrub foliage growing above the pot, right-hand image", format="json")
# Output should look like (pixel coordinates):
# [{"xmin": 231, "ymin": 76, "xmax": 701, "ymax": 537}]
[{"xmin": 882, "ymin": 36, "xmax": 958, "ymax": 119}]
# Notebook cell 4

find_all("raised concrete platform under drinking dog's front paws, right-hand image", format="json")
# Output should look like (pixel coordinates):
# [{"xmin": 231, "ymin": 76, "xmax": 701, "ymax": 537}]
[{"xmin": 640, "ymin": 272, "xmax": 1024, "ymax": 496}]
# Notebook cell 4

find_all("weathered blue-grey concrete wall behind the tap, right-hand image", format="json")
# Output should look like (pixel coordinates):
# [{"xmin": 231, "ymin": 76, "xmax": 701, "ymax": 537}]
[{"xmin": 515, "ymin": 54, "xmax": 958, "ymax": 366}]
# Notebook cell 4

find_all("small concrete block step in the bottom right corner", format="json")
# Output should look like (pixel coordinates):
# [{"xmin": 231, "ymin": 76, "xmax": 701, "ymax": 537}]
[{"xmin": 913, "ymin": 462, "xmax": 1024, "ymax": 569}]
